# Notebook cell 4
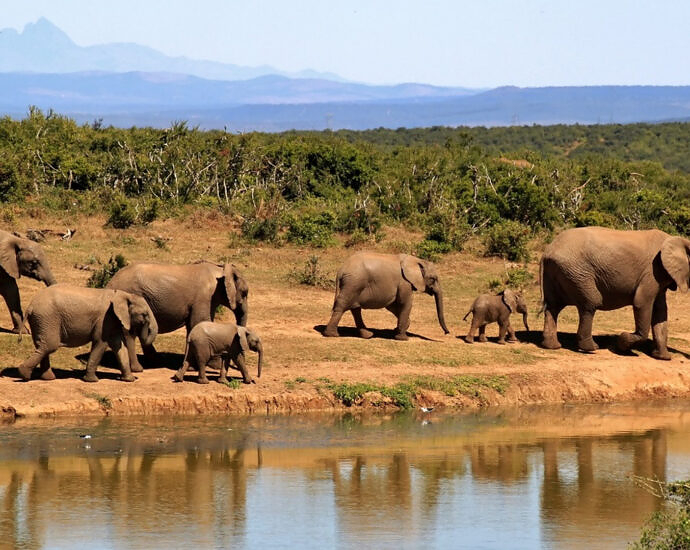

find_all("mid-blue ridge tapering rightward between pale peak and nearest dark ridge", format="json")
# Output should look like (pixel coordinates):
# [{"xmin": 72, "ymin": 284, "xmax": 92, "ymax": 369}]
[{"xmin": 0, "ymin": 72, "xmax": 482, "ymax": 115}]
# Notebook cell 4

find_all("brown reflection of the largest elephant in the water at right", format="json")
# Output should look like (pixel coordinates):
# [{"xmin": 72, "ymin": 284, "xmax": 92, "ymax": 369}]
[{"xmin": 541, "ymin": 430, "xmax": 667, "ymax": 528}]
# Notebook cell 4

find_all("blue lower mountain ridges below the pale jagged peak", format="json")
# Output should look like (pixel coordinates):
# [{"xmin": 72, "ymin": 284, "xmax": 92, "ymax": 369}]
[{"xmin": 0, "ymin": 77, "xmax": 690, "ymax": 131}]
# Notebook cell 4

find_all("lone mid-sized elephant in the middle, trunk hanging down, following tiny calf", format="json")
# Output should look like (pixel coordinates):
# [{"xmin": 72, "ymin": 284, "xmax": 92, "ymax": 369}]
[{"xmin": 323, "ymin": 252, "xmax": 448, "ymax": 340}]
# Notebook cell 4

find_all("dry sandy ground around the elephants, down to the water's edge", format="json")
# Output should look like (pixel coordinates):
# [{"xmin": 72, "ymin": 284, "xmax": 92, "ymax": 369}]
[{"xmin": 0, "ymin": 211, "xmax": 690, "ymax": 418}]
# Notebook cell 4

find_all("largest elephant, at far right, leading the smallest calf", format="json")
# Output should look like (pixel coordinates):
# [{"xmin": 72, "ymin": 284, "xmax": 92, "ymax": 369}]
[{"xmin": 540, "ymin": 227, "xmax": 690, "ymax": 359}]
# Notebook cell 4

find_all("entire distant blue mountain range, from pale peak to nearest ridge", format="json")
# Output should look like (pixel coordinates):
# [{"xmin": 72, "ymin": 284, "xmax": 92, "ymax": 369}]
[{"xmin": 0, "ymin": 19, "xmax": 690, "ymax": 131}]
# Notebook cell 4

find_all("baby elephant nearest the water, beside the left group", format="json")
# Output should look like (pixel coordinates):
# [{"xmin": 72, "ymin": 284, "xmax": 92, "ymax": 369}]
[{"xmin": 173, "ymin": 321, "xmax": 264, "ymax": 384}]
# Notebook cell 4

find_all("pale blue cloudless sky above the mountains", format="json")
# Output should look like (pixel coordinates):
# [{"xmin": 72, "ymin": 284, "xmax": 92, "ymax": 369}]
[{"xmin": 0, "ymin": 0, "xmax": 690, "ymax": 87}]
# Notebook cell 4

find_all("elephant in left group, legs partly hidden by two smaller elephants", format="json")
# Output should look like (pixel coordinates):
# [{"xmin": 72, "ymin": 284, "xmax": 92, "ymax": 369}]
[{"xmin": 107, "ymin": 262, "xmax": 249, "ymax": 372}]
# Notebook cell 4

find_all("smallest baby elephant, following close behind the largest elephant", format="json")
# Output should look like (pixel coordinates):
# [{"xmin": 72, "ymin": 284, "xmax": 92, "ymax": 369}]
[{"xmin": 462, "ymin": 288, "xmax": 529, "ymax": 344}]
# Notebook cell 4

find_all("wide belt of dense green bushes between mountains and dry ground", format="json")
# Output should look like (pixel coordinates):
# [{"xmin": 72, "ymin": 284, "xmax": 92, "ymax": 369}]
[{"xmin": 0, "ymin": 109, "xmax": 690, "ymax": 261}]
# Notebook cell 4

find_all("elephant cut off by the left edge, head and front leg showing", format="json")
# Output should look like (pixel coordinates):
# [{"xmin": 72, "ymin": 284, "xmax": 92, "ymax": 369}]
[{"xmin": 0, "ymin": 231, "xmax": 57, "ymax": 333}]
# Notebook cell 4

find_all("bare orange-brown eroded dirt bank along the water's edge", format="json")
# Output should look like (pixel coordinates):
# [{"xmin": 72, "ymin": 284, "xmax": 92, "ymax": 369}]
[{"xmin": 0, "ymin": 344, "xmax": 690, "ymax": 418}]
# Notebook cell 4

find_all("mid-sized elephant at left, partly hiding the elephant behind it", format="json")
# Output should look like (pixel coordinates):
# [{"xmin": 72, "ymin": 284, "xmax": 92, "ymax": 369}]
[{"xmin": 19, "ymin": 284, "xmax": 158, "ymax": 382}]
